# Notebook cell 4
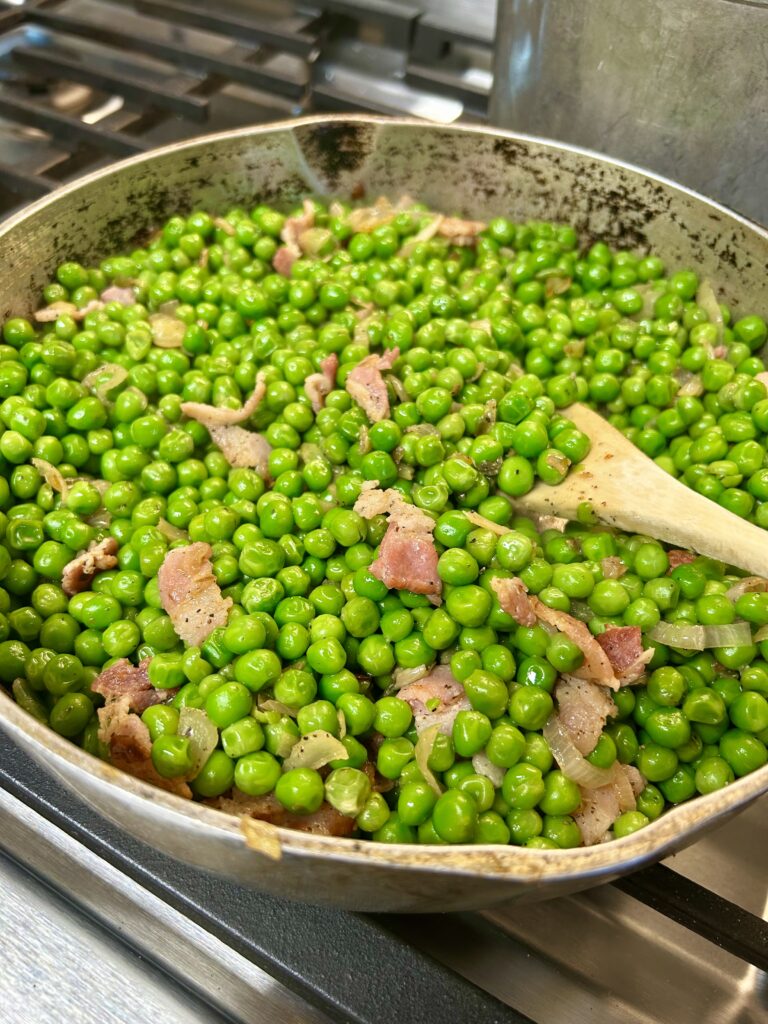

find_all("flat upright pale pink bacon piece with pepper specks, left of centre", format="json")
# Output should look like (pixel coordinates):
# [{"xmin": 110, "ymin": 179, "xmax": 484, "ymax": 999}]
[{"xmin": 158, "ymin": 542, "xmax": 232, "ymax": 646}]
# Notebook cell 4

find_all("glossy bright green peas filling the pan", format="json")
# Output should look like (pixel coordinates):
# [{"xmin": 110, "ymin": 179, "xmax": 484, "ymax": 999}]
[{"xmin": 0, "ymin": 197, "xmax": 768, "ymax": 848}]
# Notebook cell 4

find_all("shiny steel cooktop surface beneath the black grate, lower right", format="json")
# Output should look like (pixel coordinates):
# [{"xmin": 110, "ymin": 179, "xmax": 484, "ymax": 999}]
[{"xmin": 423, "ymin": 798, "xmax": 768, "ymax": 1024}]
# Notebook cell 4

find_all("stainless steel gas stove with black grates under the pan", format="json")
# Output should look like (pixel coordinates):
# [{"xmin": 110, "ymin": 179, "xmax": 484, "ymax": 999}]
[{"xmin": 0, "ymin": 0, "xmax": 768, "ymax": 1024}]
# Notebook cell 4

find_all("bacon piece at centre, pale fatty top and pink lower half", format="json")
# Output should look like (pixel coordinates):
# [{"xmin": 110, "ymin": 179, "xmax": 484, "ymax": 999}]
[{"xmin": 354, "ymin": 485, "xmax": 442, "ymax": 603}]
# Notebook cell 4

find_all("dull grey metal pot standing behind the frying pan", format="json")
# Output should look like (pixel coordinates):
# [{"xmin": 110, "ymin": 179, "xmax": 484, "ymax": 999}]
[{"xmin": 489, "ymin": 0, "xmax": 768, "ymax": 223}]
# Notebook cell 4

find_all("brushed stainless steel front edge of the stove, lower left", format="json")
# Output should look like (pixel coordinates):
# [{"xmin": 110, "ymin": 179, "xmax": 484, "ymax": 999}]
[{"xmin": 0, "ymin": 790, "xmax": 328, "ymax": 1024}]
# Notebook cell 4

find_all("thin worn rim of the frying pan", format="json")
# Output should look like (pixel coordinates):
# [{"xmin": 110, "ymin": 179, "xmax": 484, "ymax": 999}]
[{"xmin": 0, "ymin": 114, "xmax": 768, "ymax": 884}]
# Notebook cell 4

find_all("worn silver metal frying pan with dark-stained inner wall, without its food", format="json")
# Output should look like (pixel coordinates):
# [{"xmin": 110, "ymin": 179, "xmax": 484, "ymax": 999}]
[{"xmin": 0, "ymin": 116, "xmax": 768, "ymax": 911}]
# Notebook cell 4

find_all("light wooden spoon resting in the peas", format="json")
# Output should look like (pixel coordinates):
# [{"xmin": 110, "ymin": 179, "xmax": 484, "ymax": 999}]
[{"xmin": 518, "ymin": 403, "xmax": 768, "ymax": 577}]
